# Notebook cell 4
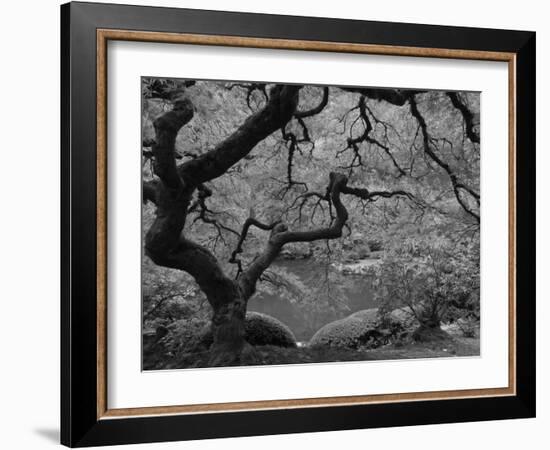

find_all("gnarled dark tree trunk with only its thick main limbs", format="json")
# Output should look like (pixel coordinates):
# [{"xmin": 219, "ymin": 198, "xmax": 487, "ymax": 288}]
[{"xmin": 143, "ymin": 85, "xmax": 424, "ymax": 365}]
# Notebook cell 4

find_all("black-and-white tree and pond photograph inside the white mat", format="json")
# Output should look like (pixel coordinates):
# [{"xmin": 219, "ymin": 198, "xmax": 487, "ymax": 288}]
[{"xmin": 141, "ymin": 77, "xmax": 482, "ymax": 370}]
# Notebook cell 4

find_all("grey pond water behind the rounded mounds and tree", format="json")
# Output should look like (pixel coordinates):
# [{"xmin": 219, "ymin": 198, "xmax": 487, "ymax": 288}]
[{"xmin": 248, "ymin": 258, "xmax": 380, "ymax": 341}]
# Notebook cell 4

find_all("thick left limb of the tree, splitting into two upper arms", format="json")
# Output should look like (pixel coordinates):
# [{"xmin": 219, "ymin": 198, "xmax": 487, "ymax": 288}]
[{"xmin": 145, "ymin": 85, "xmax": 300, "ymax": 312}]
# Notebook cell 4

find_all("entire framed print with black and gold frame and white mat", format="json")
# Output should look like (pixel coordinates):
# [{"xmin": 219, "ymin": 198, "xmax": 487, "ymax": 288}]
[{"xmin": 61, "ymin": 3, "xmax": 535, "ymax": 447}]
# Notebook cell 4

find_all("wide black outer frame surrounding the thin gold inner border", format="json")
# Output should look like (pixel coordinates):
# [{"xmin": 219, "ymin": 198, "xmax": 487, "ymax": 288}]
[{"xmin": 60, "ymin": 2, "xmax": 536, "ymax": 447}]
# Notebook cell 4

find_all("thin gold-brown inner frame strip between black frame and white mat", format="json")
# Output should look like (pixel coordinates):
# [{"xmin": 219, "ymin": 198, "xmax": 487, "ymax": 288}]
[{"xmin": 96, "ymin": 29, "xmax": 516, "ymax": 420}]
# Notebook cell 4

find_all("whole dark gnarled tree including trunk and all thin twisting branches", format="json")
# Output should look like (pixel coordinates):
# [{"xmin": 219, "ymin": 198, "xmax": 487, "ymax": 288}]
[{"xmin": 142, "ymin": 83, "xmax": 479, "ymax": 365}]
